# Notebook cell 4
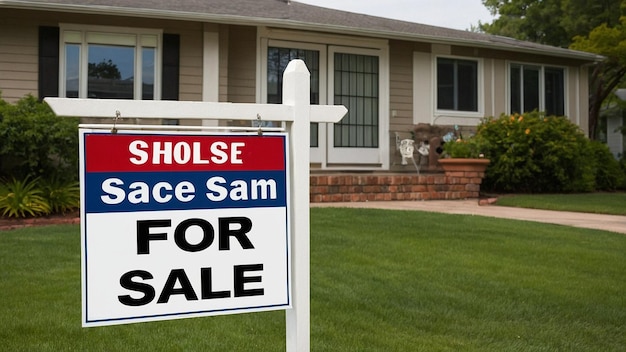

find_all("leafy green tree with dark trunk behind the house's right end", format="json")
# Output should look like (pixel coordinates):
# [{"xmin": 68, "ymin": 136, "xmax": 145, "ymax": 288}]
[{"xmin": 478, "ymin": 0, "xmax": 626, "ymax": 138}]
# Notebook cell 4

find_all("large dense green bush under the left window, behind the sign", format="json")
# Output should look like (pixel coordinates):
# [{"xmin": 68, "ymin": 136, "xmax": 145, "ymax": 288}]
[{"xmin": 0, "ymin": 95, "xmax": 78, "ymax": 180}]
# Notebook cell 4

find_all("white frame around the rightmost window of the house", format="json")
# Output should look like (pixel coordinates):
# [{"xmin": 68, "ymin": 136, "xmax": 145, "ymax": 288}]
[{"xmin": 506, "ymin": 61, "xmax": 569, "ymax": 116}]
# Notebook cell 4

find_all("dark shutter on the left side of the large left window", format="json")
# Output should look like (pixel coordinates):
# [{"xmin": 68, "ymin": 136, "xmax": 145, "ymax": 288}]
[{"xmin": 39, "ymin": 27, "xmax": 59, "ymax": 100}]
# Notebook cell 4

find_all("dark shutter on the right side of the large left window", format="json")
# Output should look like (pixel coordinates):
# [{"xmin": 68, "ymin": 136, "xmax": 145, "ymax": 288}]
[{"xmin": 161, "ymin": 33, "xmax": 180, "ymax": 100}]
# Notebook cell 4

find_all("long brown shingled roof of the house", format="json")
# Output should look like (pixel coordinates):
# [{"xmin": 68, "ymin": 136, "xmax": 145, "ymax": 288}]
[{"xmin": 0, "ymin": 0, "xmax": 602, "ymax": 61}]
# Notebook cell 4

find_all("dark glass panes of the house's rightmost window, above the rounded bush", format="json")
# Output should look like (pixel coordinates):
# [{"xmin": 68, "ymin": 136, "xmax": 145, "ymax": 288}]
[{"xmin": 510, "ymin": 64, "xmax": 565, "ymax": 116}]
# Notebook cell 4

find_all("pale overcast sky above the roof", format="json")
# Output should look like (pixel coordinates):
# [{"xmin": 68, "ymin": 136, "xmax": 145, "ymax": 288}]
[{"xmin": 294, "ymin": 0, "xmax": 493, "ymax": 30}]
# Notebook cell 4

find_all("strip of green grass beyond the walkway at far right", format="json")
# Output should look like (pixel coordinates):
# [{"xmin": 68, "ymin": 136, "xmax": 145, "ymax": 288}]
[{"xmin": 496, "ymin": 192, "xmax": 626, "ymax": 215}]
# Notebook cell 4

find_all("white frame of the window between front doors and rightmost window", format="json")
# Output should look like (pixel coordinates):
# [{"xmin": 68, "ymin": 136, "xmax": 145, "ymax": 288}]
[{"xmin": 432, "ymin": 55, "xmax": 485, "ymax": 118}]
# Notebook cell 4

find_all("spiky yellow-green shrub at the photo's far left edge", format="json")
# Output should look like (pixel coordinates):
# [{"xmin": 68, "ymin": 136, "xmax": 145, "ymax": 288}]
[{"xmin": 0, "ymin": 177, "xmax": 50, "ymax": 218}]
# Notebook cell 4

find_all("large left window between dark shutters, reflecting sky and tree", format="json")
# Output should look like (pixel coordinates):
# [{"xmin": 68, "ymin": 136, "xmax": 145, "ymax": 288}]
[{"xmin": 60, "ymin": 26, "xmax": 161, "ymax": 100}]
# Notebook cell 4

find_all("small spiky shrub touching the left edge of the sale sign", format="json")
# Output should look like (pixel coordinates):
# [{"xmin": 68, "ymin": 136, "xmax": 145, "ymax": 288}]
[{"xmin": 40, "ymin": 177, "xmax": 80, "ymax": 214}]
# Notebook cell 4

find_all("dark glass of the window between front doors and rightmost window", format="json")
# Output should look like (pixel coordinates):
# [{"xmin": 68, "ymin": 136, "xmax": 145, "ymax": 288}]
[{"xmin": 437, "ymin": 58, "xmax": 478, "ymax": 112}]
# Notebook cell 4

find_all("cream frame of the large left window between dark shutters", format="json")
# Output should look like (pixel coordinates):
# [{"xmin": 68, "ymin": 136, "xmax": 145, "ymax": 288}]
[{"xmin": 59, "ymin": 24, "xmax": 163, "ymax": 100}]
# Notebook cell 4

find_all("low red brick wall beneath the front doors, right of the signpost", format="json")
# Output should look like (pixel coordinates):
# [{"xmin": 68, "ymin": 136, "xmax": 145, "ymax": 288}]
[{"xmin": 310, "ymin": 172, "xmax": 484, "ymax": 203}]
